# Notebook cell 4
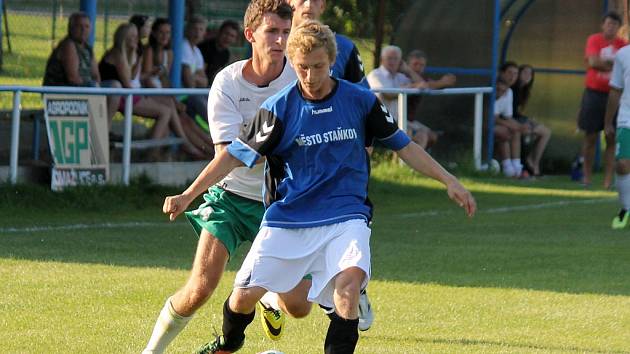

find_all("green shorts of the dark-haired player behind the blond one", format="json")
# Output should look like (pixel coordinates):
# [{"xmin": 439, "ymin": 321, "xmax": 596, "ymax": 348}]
[{"xmin": 186, "ymin": 186, "xmax": 265, "ymax": 257}]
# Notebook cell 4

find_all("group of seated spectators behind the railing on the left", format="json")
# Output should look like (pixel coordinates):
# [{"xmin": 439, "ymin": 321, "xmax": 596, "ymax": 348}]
[{"xmin": 43, "ymin": 12, "xmax": 240, "ymax": 160}]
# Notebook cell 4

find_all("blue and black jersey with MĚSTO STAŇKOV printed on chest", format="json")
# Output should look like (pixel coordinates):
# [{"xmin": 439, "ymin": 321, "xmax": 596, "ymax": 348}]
[{"xmin": 228, "ymin": 80, "xmax": 410, "ymax": 228}]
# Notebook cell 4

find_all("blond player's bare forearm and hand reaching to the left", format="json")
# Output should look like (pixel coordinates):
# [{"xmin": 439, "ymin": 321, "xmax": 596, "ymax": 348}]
[{"xmin": 162, "ymin": 145, "xmax": 243, "ymax": 221}]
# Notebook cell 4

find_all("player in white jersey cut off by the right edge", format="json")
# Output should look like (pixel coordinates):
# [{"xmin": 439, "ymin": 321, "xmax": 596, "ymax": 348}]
[{"xmin": 604, "ymin": 46, "xmax": 630, "ymax": 229}]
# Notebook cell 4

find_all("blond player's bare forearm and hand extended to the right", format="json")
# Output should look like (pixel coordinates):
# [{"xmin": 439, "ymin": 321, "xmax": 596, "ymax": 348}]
[{"xmin": 396, "ymin": 142, "xmax": 477, "ymax": 217}]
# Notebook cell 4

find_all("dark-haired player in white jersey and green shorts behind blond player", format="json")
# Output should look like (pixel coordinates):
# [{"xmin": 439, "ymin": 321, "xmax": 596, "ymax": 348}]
[{"xmin": 143, "ymin": 0, "xmax": 296, "ymax": 353}]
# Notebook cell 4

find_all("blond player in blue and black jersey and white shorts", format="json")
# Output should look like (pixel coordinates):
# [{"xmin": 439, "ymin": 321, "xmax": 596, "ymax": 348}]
[{"xmin": 163, "ymin": 21, "xmax": 476, "ymax": 354}]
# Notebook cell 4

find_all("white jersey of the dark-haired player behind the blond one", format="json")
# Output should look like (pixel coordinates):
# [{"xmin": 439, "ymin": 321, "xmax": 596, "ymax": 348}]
[{"xmin": 208, "ymin": 60, "xmax": 297, "ymax": 202}]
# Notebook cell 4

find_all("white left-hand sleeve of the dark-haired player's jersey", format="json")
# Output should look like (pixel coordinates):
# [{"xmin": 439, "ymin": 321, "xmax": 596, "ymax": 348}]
[{"xmin": 208, "ymin": 76, "xmax": 243, "ymax": 144}]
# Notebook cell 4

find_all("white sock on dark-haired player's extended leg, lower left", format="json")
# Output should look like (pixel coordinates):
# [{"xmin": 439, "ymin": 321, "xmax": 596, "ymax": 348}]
[{"xmin": 142, "ymin": 297, "xmax": 193, "ymax": 354}]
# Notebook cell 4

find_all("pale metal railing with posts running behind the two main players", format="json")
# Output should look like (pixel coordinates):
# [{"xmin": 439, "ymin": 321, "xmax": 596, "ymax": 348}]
[{"xmin": 0, "ymin": 86, "xmax": 492, "ymax": 185}]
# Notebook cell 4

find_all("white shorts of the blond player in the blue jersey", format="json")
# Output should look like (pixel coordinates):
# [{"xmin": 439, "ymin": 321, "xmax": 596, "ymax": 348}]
[{"xmin": 234, "ymin": 219, "xmax": 372, "ymax": 307}]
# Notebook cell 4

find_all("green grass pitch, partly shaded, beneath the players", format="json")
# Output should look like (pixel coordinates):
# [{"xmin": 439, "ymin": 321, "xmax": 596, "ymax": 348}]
[{"xmin": 0, "ymin": 163, "xmax": 630, "ymax": 354}]
